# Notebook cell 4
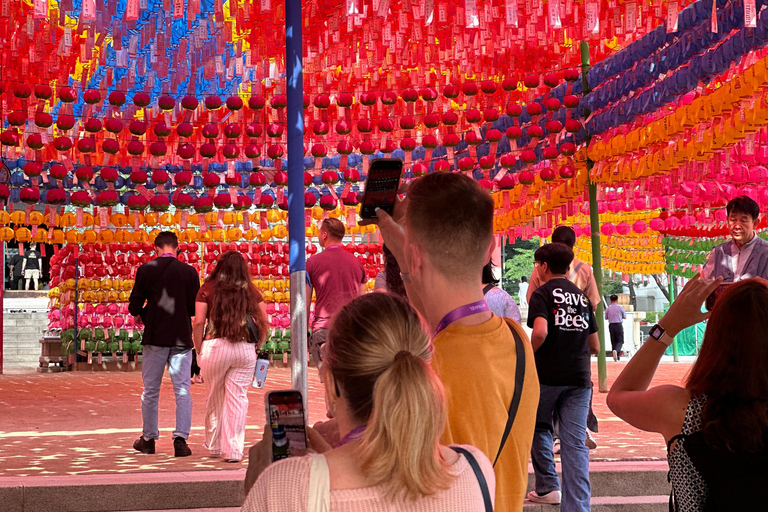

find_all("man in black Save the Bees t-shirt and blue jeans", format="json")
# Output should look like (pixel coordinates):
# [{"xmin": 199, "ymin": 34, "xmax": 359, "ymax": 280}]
[{"xmin": 528, "ymin": 243, "xmax": 600, "ymax": 512}]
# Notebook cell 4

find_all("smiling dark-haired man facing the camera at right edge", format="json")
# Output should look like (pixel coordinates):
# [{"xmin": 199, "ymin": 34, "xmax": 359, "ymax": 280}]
[{"xmin": 701, "ymin": 196, "xmax": 768, "ymax": 283}]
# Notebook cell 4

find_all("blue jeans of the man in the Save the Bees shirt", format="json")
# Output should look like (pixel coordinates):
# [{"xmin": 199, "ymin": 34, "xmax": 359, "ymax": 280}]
[{"xmin": 531, "ymin": 384, "xmax": 592, "ymax": 512}]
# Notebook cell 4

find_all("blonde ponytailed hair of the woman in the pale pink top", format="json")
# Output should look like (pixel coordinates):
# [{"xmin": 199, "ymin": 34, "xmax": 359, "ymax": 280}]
[{"xmin": 325, "ymin": 293, "xmax": 453, "ymax": 500}]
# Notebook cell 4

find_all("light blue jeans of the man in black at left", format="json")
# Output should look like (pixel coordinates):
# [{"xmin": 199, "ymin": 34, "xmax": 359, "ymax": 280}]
[{"xmin": 141, "ymin": 345, "xmax": 192, "ymax": 439}]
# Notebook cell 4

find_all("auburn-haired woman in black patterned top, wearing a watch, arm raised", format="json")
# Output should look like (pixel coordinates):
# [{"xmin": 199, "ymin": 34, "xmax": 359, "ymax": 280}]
[{"xmin": 608, "ymin": 278, "xmax": 768, "ymax": 512}]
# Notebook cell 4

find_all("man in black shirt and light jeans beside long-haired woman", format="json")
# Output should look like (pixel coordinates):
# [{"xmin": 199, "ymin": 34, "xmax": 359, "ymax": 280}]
[{"xmin": 128, "ymin": 231, "xmax": 200, "ymax": 457}]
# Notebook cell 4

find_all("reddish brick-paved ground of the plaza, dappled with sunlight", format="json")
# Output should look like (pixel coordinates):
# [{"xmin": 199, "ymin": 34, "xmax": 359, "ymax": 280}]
[{"xmin": 0, "ymin": 362, "xmax": 690, "ymax": 476}]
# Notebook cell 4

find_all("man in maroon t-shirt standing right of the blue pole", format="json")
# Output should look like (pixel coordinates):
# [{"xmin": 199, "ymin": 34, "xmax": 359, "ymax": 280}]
[{"xmin": 307, "ymin": 219, "xmax": 367, "ymax": 364}]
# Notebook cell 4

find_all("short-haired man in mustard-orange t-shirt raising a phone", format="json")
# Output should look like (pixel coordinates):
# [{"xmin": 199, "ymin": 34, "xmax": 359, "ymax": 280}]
[{"xmin": 368, "ymin": 173, "xmax": 539, "ymax": 512}]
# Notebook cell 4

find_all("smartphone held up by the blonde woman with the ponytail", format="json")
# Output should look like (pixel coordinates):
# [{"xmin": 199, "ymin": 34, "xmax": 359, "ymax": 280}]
[{"xmin": 266, "ymin": 390, "xmax": 307, "ymax": 462}]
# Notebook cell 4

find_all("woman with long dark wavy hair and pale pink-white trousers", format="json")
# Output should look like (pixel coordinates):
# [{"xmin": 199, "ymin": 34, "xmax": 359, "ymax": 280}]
[{"xmin": 194, "ymin": 251, "xmax": 267, "ymax": 462}]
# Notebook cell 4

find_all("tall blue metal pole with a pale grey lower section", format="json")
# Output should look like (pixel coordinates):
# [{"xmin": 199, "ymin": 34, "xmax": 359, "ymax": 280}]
[{"xmin": 285, "ymin": 0, "xmax": 309, "ymax": 400}]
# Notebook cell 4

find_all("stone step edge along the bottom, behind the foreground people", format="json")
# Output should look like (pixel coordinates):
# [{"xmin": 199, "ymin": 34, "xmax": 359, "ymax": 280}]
[{"xmin": 0, "ymin": 461, "xmax": 669, "ymax": 512}]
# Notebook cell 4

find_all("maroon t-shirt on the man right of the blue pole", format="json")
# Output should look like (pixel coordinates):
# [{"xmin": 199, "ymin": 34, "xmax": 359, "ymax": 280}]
[{"xmin": 307, "ymin": 246, "xmax": 367, "ymax": 331}]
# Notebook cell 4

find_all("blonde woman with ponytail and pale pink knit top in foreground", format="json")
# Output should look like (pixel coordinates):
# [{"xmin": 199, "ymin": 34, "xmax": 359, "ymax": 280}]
[{"xmin": 243, "ymin": 293, "xmax": 496, "ymax": 512}]
